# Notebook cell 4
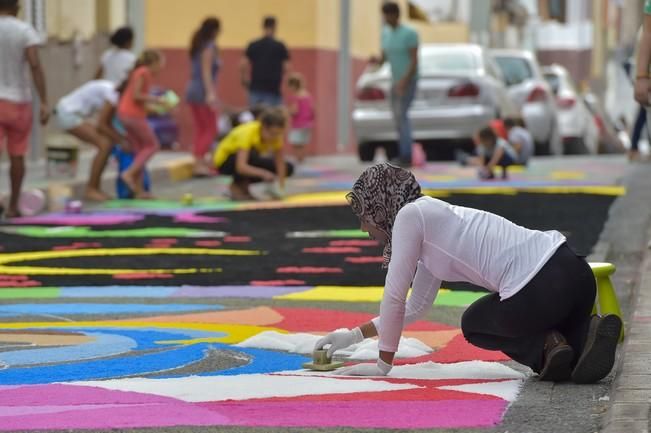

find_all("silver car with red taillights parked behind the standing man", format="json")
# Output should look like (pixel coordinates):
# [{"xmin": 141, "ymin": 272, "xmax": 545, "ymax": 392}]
[{"xmin": 353, "ymin": 44, "xmax": 516, "ymax": 161}]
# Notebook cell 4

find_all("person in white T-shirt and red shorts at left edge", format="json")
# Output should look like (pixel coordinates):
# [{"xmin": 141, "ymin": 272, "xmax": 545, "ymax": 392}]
[{"xmin": 0, "ymin": 0, "xmax": 50, "ymax": 218}]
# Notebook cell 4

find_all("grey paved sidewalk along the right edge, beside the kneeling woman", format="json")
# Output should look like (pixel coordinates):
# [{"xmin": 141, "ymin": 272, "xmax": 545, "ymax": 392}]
[{"xmin": 591, "ymin": 164, "xmax": 651, "ymax": 433}]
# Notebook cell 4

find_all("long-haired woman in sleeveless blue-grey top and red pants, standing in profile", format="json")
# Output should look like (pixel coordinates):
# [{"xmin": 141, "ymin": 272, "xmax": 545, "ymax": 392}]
[{"xmin": 186, "ymin": 17, "xmax": 220, "ymax": 176}]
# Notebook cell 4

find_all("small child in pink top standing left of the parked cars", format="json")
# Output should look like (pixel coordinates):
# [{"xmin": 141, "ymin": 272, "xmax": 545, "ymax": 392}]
[{"xmin": 287, "ymin": 74, "xmax": 314, "ymax": 162}]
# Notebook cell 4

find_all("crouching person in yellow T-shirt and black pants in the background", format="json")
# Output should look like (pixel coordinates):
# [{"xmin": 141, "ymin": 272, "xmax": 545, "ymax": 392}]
[{"xmin": 214, "ymin": 108, "xmax": 294, "ymax": 200}]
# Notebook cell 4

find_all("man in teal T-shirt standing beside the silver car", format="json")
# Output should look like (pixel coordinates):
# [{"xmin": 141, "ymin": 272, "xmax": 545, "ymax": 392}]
[{"xmin": 376, "ymin": 2, "xmax": 418, "ymax": 167}]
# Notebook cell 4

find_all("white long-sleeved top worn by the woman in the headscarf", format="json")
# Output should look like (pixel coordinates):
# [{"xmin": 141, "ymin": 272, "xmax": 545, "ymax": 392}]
[{"xmin": 373, "ymin": 197, "xmax": 566, "ymax": 352}]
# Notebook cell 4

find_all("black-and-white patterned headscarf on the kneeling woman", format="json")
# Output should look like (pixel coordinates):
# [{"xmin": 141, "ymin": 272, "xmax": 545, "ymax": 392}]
[{"xmin": 346, "ymin": 163, "xmax": 423, "ymax": 268}]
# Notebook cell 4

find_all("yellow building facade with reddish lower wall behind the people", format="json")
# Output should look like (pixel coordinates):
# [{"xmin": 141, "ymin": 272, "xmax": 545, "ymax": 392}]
[{"xmin": 29, "ymin": 0, "xmax": 477, "ymax": 154}]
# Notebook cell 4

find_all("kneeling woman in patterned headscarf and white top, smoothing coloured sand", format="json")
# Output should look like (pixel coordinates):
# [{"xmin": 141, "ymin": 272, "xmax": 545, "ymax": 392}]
[{"xmin": 316, "ymin": 164, "xmax": 622, "ymax": 383}]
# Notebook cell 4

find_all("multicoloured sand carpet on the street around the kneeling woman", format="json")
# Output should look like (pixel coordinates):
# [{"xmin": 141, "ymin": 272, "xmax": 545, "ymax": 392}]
[{"xmin": 0, "ymin": 188, "xmax": 615, "ymax": 431}]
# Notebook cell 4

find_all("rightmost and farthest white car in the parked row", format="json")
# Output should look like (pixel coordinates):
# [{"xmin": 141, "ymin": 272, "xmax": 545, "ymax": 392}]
[{"xmin": 543, "ymin": 65, "xmax": 599, "ymax": 154}]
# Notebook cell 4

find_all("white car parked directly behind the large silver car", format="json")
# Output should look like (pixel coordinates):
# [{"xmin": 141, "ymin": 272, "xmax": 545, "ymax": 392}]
[{"xmin": 490, "ymin": 50, "xmax": 563, "ymax": 155}]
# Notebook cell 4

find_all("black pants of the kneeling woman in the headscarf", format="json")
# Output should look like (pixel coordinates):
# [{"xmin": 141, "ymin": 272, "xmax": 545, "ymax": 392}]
[{"xmin": 461, "ymin": 244, "xmax": 596, "ymax": 372}]
